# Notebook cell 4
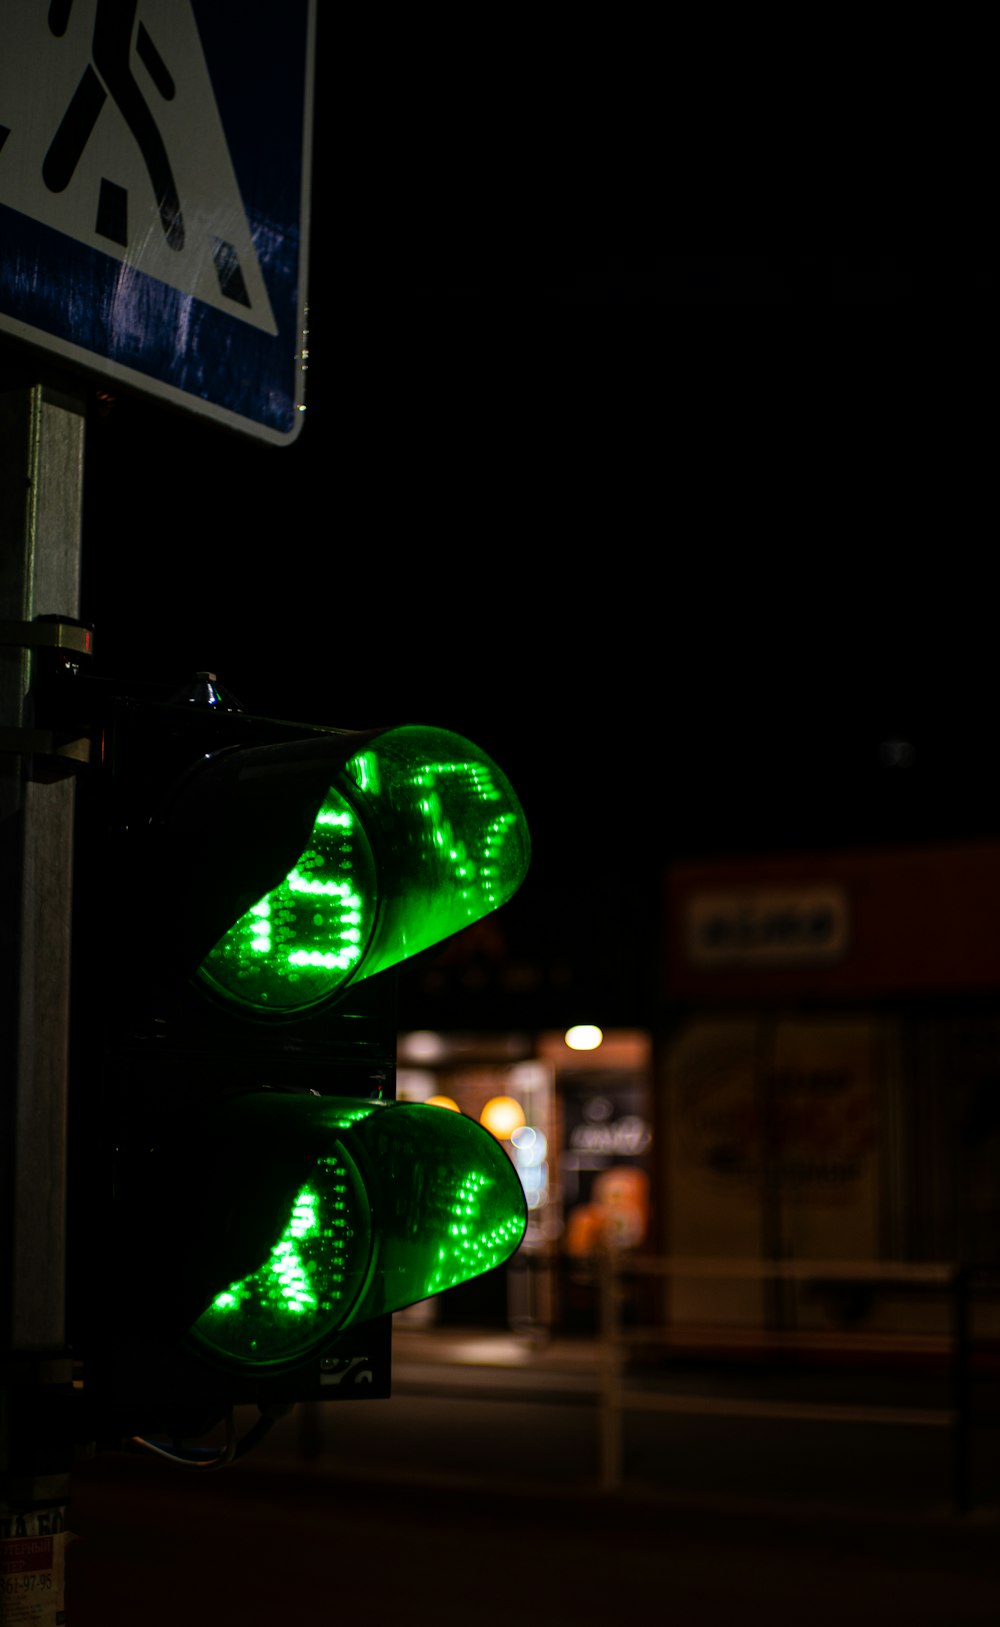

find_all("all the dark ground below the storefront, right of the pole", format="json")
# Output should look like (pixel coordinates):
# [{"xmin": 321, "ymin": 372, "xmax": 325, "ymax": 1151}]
[{"xmin": 68, "ymin": 1321, "xmax": 1000, "ymax": 1627}]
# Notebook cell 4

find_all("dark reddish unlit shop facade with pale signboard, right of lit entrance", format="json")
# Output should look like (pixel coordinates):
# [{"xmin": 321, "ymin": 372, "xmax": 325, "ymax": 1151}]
[{"xmin": 657, "ymin": 843, "xmax": 1000, "ymax": 1333}]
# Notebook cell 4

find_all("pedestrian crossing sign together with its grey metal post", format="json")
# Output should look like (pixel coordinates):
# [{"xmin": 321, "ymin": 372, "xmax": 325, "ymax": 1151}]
[{"xmin": 0, "ymin": 0, "xmax": 315, "ymax": 1607}]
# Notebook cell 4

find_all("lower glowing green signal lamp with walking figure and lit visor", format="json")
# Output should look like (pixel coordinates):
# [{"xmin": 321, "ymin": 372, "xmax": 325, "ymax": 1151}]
[{"xmin": 192, "ymin": 1097, "xmax": 527, "ymax": 1367}]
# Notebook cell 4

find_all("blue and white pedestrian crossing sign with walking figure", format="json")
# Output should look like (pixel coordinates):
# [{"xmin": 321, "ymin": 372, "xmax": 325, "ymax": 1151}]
[{"xmin": 0, "ymin": 0, "xmax": 314, "ymax": 441}]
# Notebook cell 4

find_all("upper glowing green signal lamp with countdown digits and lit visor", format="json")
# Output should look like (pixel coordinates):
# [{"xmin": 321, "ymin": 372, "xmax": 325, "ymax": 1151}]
[{"xmin": 198, "ymin": 727, "xmax": 530, "ymax": 1015}]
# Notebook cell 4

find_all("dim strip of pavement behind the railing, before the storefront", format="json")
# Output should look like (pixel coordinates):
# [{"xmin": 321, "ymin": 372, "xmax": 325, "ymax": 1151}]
[{"xmin": 275, "ymin": 1323, "xmax": 1000, "ymax": 1536}]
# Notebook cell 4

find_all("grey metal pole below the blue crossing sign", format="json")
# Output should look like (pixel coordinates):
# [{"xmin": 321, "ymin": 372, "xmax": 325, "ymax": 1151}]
[{"xmin": 0, "ymin": 373, "xmax": 85, "ymax": 1624}]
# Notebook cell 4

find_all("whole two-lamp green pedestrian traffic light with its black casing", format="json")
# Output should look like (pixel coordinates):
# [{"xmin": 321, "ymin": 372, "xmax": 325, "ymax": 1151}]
[{"xmin": 70, "ymin": 675, "xmax": 530, "ymax": 1443}]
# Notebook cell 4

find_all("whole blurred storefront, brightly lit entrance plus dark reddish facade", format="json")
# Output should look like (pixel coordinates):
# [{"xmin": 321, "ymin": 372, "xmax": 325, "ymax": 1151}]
[{"xmin": 398, "ymin": 843, "xmax": 1000, "ymax": 1344}]
